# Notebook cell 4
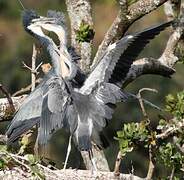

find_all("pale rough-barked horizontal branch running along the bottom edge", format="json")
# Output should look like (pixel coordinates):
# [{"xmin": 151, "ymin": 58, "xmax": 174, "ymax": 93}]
[{"xmin": 0, "ymin": 168, "xmax": 144, "ymax": 180}]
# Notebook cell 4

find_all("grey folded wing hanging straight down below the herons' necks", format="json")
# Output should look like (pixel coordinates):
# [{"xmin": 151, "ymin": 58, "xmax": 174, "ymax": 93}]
[{"xmin": 38, "ymin": 77, "xmax": 70, "ymax": 144}]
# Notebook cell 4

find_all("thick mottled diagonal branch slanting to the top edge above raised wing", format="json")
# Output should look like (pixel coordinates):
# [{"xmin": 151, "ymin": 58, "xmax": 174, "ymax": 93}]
[{"xmin": 92, "ymin": 0, "xmax": 167, "ymax": 66}]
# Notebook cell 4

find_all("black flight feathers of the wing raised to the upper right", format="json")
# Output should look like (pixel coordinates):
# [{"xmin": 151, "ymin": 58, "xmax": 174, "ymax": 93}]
[{"xmin": 109, "ymin": 21, "xmax": 172, "ymax": 84}]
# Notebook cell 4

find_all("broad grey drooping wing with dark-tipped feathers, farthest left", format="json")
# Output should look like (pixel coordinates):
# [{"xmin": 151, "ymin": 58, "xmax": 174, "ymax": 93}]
[{"xmin": 6, "ymin": 79, "xmax": 46, "ymax": 143}]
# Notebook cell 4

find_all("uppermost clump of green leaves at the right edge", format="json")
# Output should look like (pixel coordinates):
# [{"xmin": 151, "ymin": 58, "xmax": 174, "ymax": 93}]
[{"xmin": 165, "ymin": 91, "xmax": 184, "ymax": 119}]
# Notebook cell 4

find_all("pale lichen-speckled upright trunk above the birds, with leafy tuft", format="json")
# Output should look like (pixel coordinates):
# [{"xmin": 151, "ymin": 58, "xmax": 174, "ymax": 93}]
[{"xmin": 66, "ymin": 0, "xmax": 93, "ymax": 73}]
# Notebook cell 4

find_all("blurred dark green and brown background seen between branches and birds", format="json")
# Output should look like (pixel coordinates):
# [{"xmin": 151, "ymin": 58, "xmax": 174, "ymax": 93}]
[{"xmin": 0, "ymin": 0, "xmax": 184, "ymax": 176}]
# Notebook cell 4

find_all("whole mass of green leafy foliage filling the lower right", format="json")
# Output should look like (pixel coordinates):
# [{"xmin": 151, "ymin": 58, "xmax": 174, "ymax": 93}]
[{"xmin": 116, "ymin": 91, "xmax": 184, "ymax": 180}]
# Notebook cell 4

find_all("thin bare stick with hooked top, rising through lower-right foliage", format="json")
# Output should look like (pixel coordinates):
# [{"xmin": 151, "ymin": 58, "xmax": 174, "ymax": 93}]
[{"xmin": 137, "ymin": 88, "xmax": 157, "ymax": 180}]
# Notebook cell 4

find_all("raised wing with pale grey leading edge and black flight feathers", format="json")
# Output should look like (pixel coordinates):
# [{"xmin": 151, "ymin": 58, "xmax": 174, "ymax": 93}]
[{"xmin": 80, "ymin": 21, "xmax": 172, "ymax": 94}]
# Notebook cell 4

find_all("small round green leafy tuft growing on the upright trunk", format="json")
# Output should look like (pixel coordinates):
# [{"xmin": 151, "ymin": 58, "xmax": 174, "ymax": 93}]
[{"xmin": 76, "ymin": 22, "xmax": 95, "ymax": 42}]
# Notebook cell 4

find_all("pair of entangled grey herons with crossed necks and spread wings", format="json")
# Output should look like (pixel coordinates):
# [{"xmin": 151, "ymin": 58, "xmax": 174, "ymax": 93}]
[{"xmin": 7, "ymin": 11, "xmax": 172, "ymax": 169}]
